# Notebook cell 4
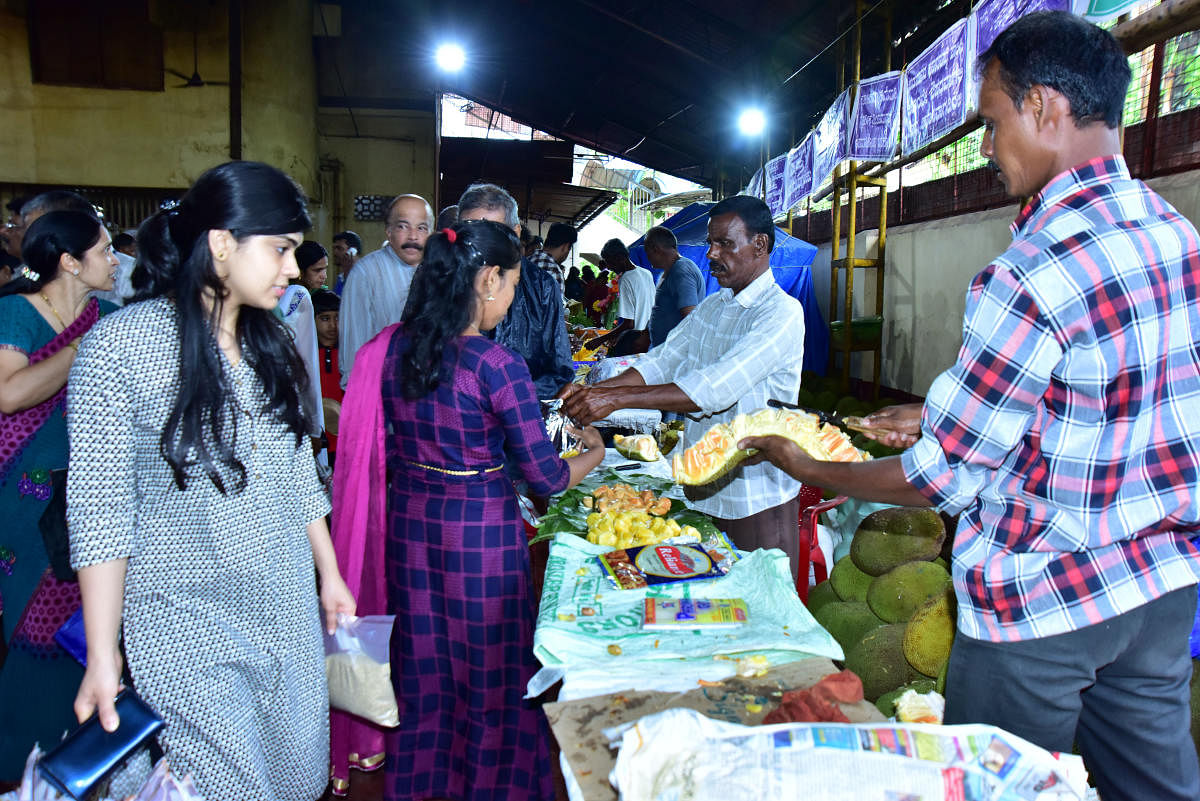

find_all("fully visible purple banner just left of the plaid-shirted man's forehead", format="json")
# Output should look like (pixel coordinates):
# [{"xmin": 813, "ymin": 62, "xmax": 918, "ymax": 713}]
[{"xmin": 901, "ymin": 19, "xmax": 973, "ymax": 156}]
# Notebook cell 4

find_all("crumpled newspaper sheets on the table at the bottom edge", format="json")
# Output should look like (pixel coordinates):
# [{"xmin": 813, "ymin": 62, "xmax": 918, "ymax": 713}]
[{"xmin": 610, "ymin": 709, "xmax": 1087, "ymax": 801}]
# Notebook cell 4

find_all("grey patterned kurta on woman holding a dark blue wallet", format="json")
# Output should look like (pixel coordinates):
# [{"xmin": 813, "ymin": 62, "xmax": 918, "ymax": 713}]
[{"xmin": 67, "ymin": 299, "xmax": 329, "ymax": 801}]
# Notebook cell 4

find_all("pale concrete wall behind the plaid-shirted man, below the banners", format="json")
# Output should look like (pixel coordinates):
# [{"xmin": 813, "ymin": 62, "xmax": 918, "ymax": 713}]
[{"xmin": 812, "ymin": 171, "xmax": 1200, "ymax": 396}]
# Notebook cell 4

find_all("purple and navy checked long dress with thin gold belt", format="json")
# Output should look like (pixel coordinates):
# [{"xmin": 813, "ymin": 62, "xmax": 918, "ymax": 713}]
[{"xmin": 382, "ymin": 330, "xmax": 570, "ymax": 801}]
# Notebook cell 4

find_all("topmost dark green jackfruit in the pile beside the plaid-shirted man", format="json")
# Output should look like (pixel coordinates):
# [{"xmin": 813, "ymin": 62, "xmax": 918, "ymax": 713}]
[{"xmin": 850, "ymin": 507, "xmax": 946, "ymax": 576}]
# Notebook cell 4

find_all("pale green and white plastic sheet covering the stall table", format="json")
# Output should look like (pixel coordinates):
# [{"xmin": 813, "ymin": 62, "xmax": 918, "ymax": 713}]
[{"xmin": 528, "ymin": 462, "xmax": 842, "ymax": 800}]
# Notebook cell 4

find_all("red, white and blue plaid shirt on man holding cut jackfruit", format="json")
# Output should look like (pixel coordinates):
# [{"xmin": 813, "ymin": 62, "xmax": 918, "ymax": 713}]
[{"xmin": 902, "ymin": 156, "xmax": 1200, "ymax": 642}]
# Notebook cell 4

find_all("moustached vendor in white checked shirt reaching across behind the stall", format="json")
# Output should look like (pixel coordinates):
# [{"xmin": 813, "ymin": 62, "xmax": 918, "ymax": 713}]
[{"xmin": 563, "ymin": 195, "xmax": 804, "ymax": 574}]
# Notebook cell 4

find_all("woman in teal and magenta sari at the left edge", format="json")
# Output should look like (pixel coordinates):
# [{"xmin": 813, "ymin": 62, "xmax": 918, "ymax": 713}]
[{"xmin": 0, "ymin": 211, "xmax": 116, "ymax": 781}]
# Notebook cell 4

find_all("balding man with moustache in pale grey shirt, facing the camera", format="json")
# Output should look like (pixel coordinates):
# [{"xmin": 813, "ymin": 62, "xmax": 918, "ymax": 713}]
[{"xmin": 337, "ymin": 194, "xmax": 433, "ymax": 389}]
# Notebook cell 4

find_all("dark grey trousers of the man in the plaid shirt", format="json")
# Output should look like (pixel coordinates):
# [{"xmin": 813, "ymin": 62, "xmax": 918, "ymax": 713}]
[{"xmin": 946, "ymin": 585, "xmax": 1200, "ymax": 801}]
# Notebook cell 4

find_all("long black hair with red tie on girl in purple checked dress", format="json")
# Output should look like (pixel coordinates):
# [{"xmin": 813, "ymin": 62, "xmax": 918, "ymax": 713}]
[{"xmin": 401, "ymin": 219, "xmax": 521, "ymax": 401}]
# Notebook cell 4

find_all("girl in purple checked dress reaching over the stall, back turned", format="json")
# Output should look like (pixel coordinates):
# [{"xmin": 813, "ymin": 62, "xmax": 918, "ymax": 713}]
[{"xmin": 335, "ymin": 221, "xmax": 604, "ymax": 801}]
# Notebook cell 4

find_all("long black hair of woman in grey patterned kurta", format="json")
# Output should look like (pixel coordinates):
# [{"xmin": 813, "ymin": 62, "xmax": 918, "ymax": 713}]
[{"xmin": 133, "ymin": 162, "xmax": 314, "ymax": 493}]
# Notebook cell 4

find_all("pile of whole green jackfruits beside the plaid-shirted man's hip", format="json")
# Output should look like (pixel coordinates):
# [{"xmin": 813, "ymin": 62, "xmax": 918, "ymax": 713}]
[{"xmin": 809, "ymin": 507, "xmax": 956, "ymax": 716}]
